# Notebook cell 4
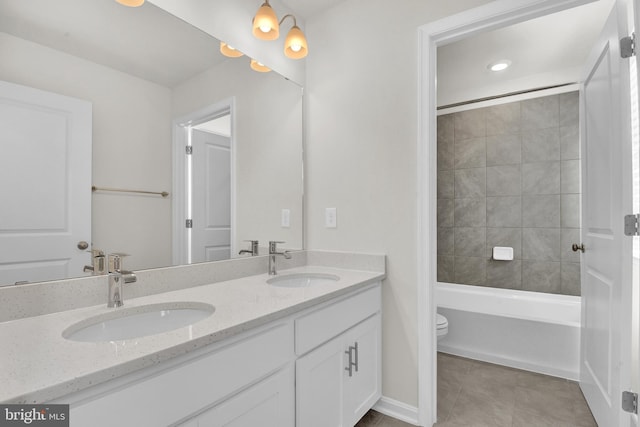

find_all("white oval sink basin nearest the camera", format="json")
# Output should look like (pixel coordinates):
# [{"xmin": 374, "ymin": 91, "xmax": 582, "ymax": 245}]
[{"xmin": 62, "ymin": 302, "xmax": 215, "ymax": 342}]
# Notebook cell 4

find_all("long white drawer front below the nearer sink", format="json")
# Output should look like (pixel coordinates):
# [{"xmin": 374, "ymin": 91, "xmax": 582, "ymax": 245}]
[{"xmin": 70, "ymin": 322, "xmax": 293, "ymax": 427}]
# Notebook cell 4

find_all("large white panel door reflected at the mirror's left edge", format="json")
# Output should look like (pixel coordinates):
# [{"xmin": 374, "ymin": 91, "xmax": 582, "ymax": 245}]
[{"xmin": 0, "ymin": 81, "xmax": 91, "ymax": 285}]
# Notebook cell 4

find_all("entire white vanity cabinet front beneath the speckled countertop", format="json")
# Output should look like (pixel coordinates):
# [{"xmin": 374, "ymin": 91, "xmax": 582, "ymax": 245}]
[{"xmin": 51, "ymin": 282, "xmax": 381, "ymax": 427}]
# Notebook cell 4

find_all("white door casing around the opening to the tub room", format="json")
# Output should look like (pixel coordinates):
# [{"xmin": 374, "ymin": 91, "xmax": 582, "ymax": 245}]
[{"xmin": 416, "ymin": 0, "xmax": 595, "ymax": 426}]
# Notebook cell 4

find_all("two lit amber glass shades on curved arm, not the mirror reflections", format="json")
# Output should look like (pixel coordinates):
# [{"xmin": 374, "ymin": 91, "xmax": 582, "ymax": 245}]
[{"xmin": 252, "ymin": 0, "xmax": 308, "ymax": 59}]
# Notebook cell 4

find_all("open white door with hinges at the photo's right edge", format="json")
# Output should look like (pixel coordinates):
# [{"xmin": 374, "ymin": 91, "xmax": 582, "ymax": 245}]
[{"xmin": 580, "ymin": 1, "xmax": 632, "ymax": 427}]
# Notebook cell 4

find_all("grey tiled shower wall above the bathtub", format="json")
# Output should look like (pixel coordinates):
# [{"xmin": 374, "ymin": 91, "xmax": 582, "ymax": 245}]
[{"xmin": 438, "ymin": 92, "xmax": 580, "ymax": 295}]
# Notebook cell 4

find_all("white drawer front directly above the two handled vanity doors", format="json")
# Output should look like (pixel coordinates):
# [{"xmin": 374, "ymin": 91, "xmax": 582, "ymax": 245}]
[{"xmin": 295, "ymin": 284, "xmax": 381, "ymax": 355}]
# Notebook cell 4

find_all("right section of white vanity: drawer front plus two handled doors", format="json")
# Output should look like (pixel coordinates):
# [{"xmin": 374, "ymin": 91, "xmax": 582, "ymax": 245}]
[{"xmin": 296, "ymin": 287, "xmax": 381, "ymax": 427}]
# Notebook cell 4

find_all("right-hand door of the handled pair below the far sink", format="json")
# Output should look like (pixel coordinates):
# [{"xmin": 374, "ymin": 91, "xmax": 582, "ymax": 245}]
[{"xmin": 344, "ymin": 314, "xmax": 382, "ymax": 426}]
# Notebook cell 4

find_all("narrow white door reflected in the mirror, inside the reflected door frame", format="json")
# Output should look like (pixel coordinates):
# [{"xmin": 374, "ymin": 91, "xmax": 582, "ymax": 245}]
[{"xmin": 191, "ymin": 129, "xmax": 231, "ymax": 262}]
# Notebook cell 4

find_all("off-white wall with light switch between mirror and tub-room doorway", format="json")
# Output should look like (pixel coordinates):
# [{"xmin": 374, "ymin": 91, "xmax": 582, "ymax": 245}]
[{"xmin": 305, "ymin": 0, "xmax": 488, "ymax": 405}]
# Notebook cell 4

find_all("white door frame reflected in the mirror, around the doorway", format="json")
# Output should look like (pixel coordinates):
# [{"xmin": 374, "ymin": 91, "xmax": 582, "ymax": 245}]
[{"xmin": 172, "ymin": 97, "xmax": 236, "ymax": 265}]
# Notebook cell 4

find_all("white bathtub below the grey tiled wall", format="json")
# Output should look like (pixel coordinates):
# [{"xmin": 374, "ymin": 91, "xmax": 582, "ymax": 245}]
[{"xmin": 436, "ymin": 283, "xmax": 580, "ymax": 380}]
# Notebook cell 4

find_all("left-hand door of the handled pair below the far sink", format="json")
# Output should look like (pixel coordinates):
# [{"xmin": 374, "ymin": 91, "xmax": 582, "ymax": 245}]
[{"xmin": 296, "ymin": 336, "xmax": 347, "ymax": 427}]
